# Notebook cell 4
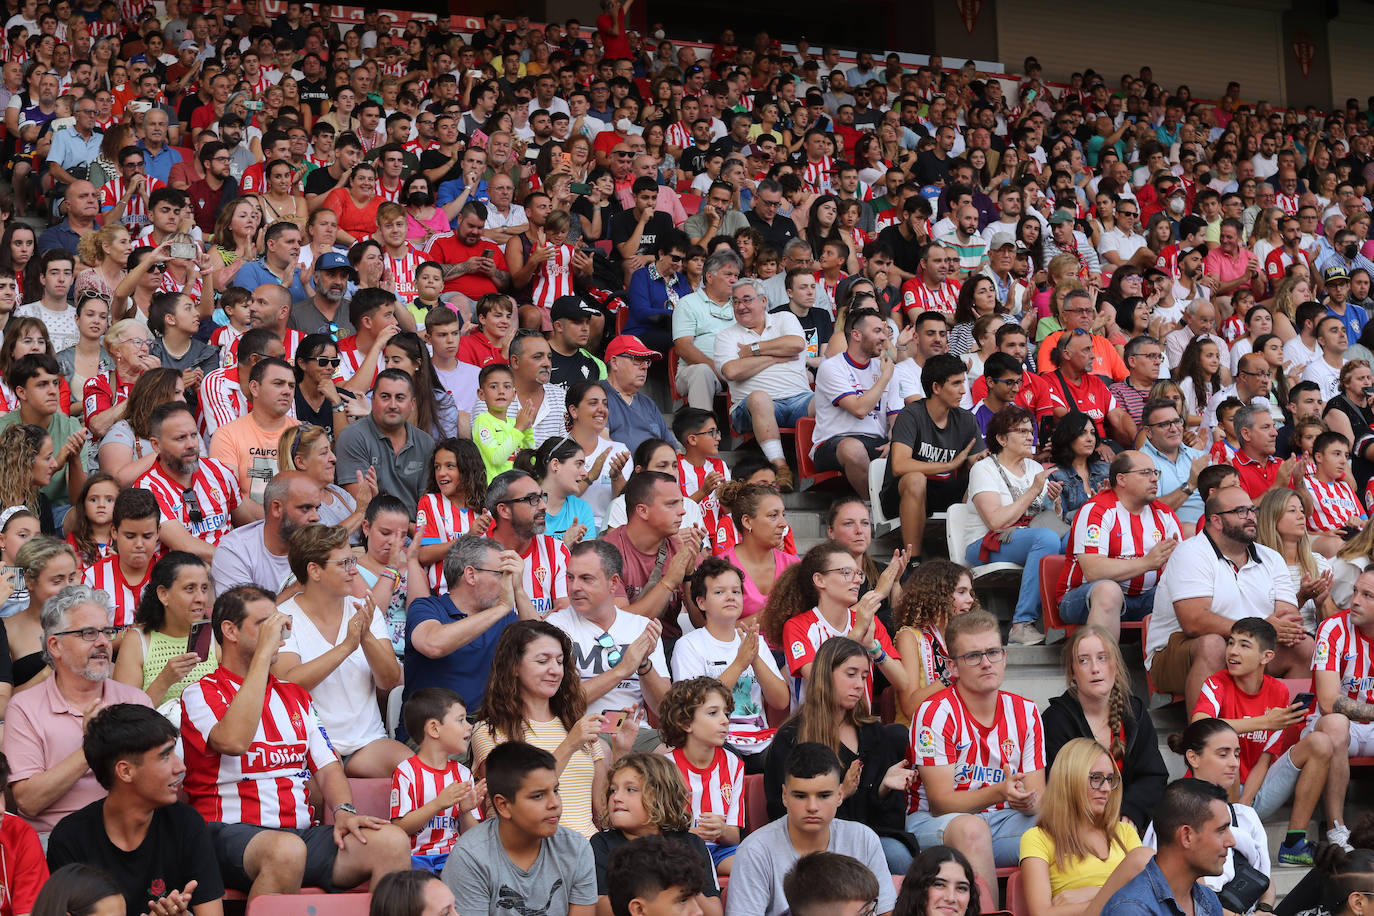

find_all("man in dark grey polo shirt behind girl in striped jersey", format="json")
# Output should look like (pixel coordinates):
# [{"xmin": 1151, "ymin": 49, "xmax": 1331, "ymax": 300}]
[{"xmin": 334, "ymin": 369, "xmax": 431, "ymax": 518}]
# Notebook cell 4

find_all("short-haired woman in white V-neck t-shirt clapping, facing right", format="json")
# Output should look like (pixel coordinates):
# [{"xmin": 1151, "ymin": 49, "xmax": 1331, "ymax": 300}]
[{"xmin": 272, "ymin": 525, "xmax": 411, "ymax": 779}]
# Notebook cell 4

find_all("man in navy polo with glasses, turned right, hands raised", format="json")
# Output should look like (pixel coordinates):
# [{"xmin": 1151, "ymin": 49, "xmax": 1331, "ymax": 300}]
[{"xmin": 397, "ymin": 534, "xmax": 537, "ymax": 740}]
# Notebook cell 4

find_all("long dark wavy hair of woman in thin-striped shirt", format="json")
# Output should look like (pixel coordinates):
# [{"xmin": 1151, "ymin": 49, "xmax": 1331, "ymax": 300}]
[{"xmin": 482, "ymin": 621, "xmax": 587, "ymax": 740}]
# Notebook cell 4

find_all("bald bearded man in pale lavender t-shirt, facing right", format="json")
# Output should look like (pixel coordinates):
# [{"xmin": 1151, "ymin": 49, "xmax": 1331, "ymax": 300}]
[{"xmin": 210, "ymin": 471, "xmax": 320, "ymax": 597}]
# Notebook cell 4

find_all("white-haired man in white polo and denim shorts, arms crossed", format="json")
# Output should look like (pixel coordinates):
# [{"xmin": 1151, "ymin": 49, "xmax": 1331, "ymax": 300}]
[{"xmin": 714, "ymin": 279, "xmax": 815, "ymax": 488}]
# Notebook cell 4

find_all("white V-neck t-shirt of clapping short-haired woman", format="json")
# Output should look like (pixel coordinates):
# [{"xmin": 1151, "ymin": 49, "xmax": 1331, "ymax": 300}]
[{"xmin": 280, "ymin": 597, "xmax": 392, "ymax": 757}]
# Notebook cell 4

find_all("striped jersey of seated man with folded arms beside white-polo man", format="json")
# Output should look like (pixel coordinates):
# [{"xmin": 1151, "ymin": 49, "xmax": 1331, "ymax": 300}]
[{"xmin": 1055, "ymin": 489, "xmax": 1183, "ymax": 602}]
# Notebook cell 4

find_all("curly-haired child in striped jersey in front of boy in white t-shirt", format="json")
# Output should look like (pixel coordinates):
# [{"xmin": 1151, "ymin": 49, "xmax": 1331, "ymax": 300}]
[{"xmin": 658, "ymin": 677, "xmax": 745, "ymax": 875}]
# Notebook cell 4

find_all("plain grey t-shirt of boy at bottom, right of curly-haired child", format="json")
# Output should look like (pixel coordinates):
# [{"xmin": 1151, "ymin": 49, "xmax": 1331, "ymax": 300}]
[{"xmin": 725, "ymin": 817, "xmax": 897, "ymax": 916}]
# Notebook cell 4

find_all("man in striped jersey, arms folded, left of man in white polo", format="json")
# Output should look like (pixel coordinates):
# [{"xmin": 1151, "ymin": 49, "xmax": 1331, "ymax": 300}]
[{"xmin": 1057, "ymin": 450, "xmax": 1187, "ymax": 639}]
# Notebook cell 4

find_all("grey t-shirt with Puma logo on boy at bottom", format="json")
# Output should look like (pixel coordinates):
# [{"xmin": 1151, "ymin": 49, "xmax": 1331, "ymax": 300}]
[{"xmin": 444, "ymin": 817, "xmax": 599, "ymax": 916}]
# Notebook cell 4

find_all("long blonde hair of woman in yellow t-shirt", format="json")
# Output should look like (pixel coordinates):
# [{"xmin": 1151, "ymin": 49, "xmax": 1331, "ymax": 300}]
[{"xmin": 1036, "ymin": 737, "xmax": 1127, "ymax": 871}]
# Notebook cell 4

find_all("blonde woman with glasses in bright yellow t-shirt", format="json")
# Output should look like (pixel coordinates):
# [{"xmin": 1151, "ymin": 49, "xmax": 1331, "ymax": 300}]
[{"xmin": 1021, "ymin": 737, "xmax": 1154, "ymax": 916}]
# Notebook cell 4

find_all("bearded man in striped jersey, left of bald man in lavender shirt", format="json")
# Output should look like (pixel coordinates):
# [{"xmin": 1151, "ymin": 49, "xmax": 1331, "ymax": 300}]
[{"xmin": 135, "ymin": 400, "xmax": 253, "ymax": 560}]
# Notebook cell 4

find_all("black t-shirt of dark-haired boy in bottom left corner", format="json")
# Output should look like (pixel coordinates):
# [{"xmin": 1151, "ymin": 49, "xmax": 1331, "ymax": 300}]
[{"xmin": 48, "ymin": 798, "xmax": 224, "ymax": 913}]
